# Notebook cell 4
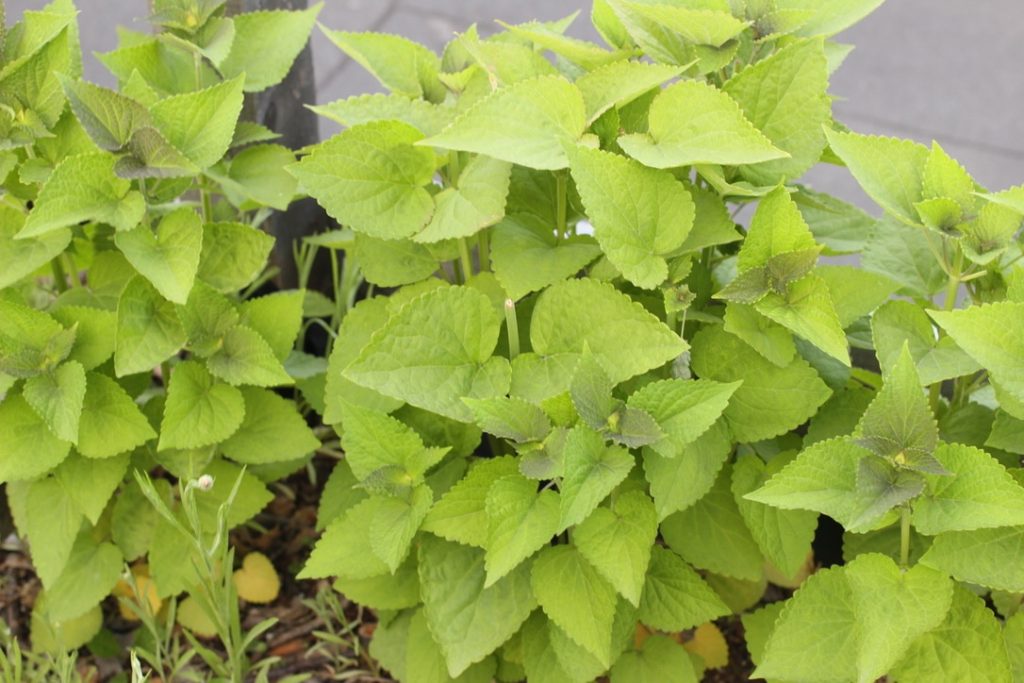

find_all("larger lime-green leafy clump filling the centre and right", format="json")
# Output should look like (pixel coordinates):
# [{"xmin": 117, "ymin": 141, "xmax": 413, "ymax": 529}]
[{"xmin": 290, "ymin": 0, "xmax": 1024, "ymax": 683}]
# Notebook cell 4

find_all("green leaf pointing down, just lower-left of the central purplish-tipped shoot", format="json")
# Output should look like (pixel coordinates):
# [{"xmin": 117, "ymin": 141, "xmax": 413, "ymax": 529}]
[{"xmin": 484, "ymin": 474, "xmax": 558, "ymax": 587}]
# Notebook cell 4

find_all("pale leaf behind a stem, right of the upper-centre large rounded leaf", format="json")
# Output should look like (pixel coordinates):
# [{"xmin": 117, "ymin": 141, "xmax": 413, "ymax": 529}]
[{"xmin": 414, "ymin": 156, "xmax": 512, "ymax": 243}]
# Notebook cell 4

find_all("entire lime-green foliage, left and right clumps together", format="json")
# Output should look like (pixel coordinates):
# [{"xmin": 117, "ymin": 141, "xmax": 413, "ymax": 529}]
[{"xmin": 0, "ymin": 0, "xmax": 1024, "ymax": 683}]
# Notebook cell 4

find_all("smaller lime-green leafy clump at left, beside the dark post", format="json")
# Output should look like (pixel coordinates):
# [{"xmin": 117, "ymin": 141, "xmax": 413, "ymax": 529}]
[{"xmin": 0, "ymin": 0, "xmax": 319, "ymax": 663}]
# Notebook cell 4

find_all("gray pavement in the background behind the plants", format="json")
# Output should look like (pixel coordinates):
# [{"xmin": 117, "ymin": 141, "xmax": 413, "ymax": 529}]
[{"xmin": 7, "ymin": 0, "xmax": 1024, "ymax": 204}]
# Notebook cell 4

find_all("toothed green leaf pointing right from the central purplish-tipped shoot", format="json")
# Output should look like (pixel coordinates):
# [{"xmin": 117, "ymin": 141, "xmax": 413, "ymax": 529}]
[{"xmin": 629, "ymin": 379, "xmax": 740, "ymax": 458}]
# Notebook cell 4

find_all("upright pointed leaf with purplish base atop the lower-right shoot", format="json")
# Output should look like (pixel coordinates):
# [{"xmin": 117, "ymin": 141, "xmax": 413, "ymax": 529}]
[{"xmin": 857, "ymin": 346, "xmax": 941, "ymax": 466}]
